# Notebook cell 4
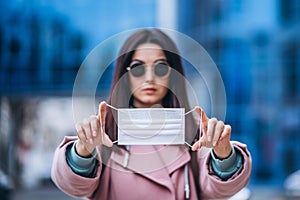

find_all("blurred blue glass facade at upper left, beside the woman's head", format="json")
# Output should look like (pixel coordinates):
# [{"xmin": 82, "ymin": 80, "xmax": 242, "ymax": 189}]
[{"xmin": 0, "ymin": 1, "xmax": 156, "ymax": 96}]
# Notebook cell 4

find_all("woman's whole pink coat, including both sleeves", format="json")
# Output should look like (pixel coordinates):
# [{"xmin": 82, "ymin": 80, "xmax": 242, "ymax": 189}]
[{"xmin": 51, "ymin": 137, "xmax": 252, "ymax": 200}]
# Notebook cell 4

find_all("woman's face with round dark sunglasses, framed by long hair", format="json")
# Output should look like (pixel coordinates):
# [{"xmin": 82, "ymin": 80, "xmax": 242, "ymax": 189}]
[{"xmin": 128, "ymin": 43, "xmax": 171, "ymax": 108}]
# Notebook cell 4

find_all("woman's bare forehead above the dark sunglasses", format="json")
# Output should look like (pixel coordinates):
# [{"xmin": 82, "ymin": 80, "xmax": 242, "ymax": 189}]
[{"xmin": 132, "ymin": 43, "xmax": 166, "ymax": 60}]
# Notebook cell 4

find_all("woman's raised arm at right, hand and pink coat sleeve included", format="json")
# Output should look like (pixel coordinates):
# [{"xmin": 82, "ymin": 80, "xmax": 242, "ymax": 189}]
[{"xmin": 192, "ymin": 107, "xmax": 252, "ymax": 199}]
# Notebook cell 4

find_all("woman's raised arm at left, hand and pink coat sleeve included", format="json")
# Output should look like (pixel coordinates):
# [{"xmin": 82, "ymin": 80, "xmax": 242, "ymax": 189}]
[{"xmin": 51, "ymin": 102, "xmax": 112, "ymax": 197}]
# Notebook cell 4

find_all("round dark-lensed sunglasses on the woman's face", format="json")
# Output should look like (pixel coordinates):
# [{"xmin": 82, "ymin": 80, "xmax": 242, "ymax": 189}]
[{"xmin": 126, "ymin": 60, "xmax": 171, "ymax": 77}]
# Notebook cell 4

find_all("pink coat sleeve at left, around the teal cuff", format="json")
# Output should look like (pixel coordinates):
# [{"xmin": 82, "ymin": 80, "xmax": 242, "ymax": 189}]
[{"xmin": 51, "ymin": 136, "xmax": 102, "ymax": 197}]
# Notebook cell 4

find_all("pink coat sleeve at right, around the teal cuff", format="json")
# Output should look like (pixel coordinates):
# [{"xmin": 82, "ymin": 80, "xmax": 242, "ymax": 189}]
[{"xmin": 198, "ymin": 142, "xmax": 252, "ymax": 199}]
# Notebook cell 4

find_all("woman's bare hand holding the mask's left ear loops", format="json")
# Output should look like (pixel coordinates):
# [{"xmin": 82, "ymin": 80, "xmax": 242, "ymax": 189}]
[{"xmin": 75, "ymin": 101, "xmax": 113, "ymax": 157}]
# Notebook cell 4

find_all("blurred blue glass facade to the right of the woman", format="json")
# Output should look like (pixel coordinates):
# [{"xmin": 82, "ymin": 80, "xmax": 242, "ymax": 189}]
[{"xmin": 178, "ymin": 0, "xmax": 300, "ymax": 185}]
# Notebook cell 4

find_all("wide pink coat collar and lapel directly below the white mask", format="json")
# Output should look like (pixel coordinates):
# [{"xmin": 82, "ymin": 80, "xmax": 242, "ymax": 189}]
[{"xmin": 111, "ymin": 145, "xmax": 190, "ymax": 190}]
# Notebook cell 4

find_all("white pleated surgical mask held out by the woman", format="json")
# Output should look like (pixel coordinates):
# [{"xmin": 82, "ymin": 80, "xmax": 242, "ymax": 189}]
[{"xmin": 118, "ymin": 108, "xmax": 185, "ymax": 145}]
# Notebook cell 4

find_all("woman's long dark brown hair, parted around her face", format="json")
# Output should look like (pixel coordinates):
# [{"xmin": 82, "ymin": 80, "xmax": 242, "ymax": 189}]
[{"xmin": 106, "ymin": 28, "xmax": 197, "ymax": 143}]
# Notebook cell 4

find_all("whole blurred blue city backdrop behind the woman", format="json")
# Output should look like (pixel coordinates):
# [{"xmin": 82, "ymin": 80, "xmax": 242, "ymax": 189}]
[{"xmin": 0, "ymin": 0, "xmax": 300, "ymax": 200}]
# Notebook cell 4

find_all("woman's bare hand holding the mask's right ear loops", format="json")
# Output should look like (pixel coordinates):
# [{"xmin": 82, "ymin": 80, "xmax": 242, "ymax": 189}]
[{"xmin": 192, "ymin": 106, "xmax": 231, "ymax": 159}]
